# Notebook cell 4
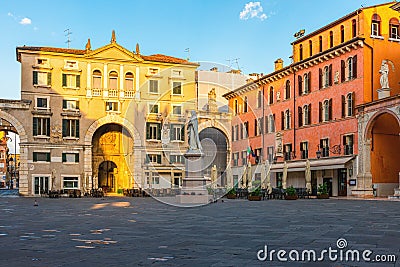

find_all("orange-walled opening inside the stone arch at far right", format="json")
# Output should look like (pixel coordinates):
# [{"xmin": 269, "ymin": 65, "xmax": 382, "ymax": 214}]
[{"xmin": 364, "ymin": 109, "xmax": 400, "ymax": 196}]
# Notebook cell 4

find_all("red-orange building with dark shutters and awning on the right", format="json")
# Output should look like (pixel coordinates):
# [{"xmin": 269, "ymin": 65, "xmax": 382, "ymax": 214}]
[{"xmin": 224, "ymin": 2, "xmax": 400, "ymax": 196}]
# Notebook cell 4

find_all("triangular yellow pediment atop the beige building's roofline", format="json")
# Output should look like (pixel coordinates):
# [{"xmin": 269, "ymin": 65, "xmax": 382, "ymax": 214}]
[{"xmin": 86, "ymin": 43, "xmax": 143, "ymax": 62}]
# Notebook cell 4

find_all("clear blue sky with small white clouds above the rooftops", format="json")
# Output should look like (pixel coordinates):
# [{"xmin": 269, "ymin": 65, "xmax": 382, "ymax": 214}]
[{"xmin": 0, "ymin": 0, "xmax": 383, "ymax": 99}]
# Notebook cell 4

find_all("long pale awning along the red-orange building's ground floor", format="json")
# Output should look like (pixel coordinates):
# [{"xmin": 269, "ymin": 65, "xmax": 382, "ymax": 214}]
[{"xmin": 271, "ymin": 156, "xmax": 354, "ymax": 172}]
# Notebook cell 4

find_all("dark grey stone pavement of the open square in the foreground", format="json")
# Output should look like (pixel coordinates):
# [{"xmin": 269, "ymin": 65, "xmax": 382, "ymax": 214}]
[{"xmin": 0, "ymin": 197, "xmax": 400, "ymax": 266}]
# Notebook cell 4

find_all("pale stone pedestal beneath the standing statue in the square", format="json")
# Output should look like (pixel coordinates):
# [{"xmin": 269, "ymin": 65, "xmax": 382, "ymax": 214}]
[{"xmin": 176, "ymin": 150, "xmax": 212, "ymax": 204}]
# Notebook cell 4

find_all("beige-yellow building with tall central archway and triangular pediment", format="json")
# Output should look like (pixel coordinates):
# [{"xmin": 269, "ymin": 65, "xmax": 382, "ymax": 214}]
[{"xmin": 0, "ymin": 32, "xmax": 198, "ymax": 195}]
